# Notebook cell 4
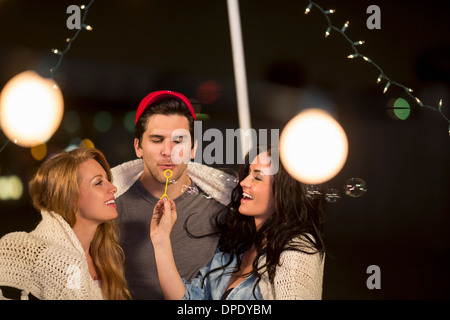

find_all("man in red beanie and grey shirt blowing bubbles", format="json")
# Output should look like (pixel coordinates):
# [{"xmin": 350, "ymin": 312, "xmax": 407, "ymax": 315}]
[{"xmin": 111, "ymin": 91, "xmax": 233, "ymax": 300}]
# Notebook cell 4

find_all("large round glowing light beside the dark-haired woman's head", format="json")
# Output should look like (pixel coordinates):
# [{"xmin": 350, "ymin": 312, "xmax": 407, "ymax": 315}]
[{"xmin": 280, "ymin": 109, "xmax": 348, "ymax": 185}]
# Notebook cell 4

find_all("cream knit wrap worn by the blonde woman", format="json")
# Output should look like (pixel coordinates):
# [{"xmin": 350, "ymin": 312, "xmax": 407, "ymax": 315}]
[{"xmin": 0, "ymin": 211, "xmax": 103, "ymax": 300}]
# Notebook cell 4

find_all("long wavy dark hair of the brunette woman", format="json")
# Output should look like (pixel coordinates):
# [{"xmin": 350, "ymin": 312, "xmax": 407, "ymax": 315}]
[{"xmin": 205, "ymin": 146, "xmax": 326, "ymax": 298}]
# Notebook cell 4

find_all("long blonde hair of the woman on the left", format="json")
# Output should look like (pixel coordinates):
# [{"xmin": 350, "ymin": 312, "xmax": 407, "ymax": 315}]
[{"xmin": 29, "ymin": 148, "xmax": 131, "ymax": 300}]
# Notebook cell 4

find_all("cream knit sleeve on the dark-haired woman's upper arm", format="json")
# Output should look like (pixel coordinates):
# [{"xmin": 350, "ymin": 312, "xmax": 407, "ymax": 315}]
[{"xmin": 274, "ymin": 250, "xmax": 324, "ymax": 300}]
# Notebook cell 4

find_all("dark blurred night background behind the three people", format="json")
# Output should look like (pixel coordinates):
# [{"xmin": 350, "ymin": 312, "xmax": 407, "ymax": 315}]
[{"xmin": 0, "ymin": 0, "xmax": 450, "ymax": 299}]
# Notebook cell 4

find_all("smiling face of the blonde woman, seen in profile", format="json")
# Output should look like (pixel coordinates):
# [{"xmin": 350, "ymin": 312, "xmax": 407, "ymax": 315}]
[{"xmin": 76, "ymin": 159, "xmax": 117, "ymax": 225}]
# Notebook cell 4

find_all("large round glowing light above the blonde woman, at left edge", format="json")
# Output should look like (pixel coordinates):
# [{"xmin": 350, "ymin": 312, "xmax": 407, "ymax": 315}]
[{"xmin": 0, "ymin": 71, "xmax": 64, "ymax": 147}]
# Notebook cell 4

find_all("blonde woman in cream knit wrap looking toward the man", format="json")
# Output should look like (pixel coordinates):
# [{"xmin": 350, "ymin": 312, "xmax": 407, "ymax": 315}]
[{"xmin": 0, "ymin": 148, "xmax": 130, "ymax": 300}]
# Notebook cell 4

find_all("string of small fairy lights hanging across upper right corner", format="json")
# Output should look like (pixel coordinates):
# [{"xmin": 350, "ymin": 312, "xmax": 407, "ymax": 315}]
[{"xmin": 305, "ymin": 0, "xmax": 450, "ymax": 135}]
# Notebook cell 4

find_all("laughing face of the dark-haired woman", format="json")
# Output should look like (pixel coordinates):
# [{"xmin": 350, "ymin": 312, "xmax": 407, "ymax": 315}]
[{"xmin": 239, "ymin": 152, "xmax": 275, "ymax": 227}]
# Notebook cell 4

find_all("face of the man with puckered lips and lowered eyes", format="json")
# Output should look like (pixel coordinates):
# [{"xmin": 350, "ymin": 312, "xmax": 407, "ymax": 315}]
[{"xmin": 134, "ymin": 114, "xmax": 195, "ymax": 184}]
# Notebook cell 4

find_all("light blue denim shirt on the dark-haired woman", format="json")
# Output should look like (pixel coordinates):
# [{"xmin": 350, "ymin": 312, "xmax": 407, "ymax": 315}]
[{"xmin": 183, "ymin": 251, "xmax": 262, "ymax": 300}]
